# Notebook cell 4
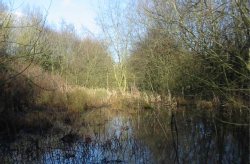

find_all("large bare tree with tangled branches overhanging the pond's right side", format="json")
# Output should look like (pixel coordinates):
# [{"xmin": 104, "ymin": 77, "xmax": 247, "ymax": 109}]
[{"xmin": 141, "ymin": 0, "xmax": 250, "ymax": 99}]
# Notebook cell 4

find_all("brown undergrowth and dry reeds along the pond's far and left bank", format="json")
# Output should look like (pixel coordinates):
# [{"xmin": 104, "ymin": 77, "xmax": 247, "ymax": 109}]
[{"xmin": 0, "ymin": 63, "xmax": 247, "ymax": 139}]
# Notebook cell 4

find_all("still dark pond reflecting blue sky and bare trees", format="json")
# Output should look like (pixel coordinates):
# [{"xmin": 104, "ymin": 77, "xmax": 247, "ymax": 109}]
[{"xmin": 0, "ymin": 108, "xmax": 250, "ymax": 164}]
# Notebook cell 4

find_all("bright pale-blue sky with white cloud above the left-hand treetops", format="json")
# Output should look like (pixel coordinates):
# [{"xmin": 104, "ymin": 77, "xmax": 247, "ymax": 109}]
[{"xmin": 3, "ymin": 0, "xmax": 101, "ymax": 35}]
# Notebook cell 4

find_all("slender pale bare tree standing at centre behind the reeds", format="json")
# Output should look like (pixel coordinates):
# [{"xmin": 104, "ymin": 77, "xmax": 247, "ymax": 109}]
[{"xmin": 98, "ymin": 1, "xmax": 140, "ymax": 91}]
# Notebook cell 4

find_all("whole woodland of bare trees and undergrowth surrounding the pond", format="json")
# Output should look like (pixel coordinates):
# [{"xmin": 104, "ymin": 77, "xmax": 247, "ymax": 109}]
[{"xmin": 0, "ymin": 0, "xmax": 250, "ymax": 151}]
